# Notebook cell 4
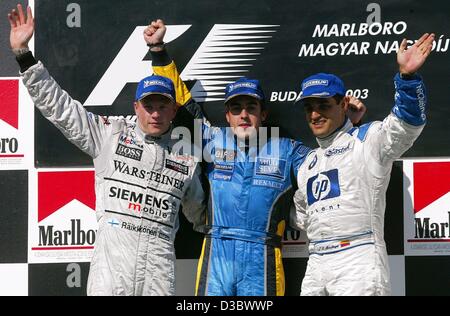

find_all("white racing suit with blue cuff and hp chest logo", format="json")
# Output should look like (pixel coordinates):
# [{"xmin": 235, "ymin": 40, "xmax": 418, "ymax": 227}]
[{"xmin": 291, "ymin": 75, "xmax": 426, "ymax": 296}]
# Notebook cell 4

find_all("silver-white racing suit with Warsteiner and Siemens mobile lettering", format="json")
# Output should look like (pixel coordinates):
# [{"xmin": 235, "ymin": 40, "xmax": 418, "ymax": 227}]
[{"xmin": 21, "ymin": 62, "xmax": 205, "ymax": 295}]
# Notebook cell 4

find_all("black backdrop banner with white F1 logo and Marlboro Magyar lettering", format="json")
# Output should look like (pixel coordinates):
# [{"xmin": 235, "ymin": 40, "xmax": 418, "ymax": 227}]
[{"xmin": 36, "ymin": 0, "xmax": 450, "ymax": 166}]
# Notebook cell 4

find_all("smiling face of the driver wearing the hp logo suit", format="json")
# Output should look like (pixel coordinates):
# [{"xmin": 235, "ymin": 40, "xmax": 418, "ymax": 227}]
[{"xmin": 303, "ymin": 98, "xmax": 348, "ymax": 138}]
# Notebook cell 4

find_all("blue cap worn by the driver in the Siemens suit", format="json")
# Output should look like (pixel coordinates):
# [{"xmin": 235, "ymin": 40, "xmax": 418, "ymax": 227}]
[{"xmin": 136, "ymin": 75, "xmax": 176, "ymax": 102}]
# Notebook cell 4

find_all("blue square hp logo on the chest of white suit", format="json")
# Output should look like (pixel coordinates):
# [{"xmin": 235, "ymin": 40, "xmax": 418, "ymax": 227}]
[{"xmin": 307, "ymin": 169, "xmax": 341, "ymax": 206}]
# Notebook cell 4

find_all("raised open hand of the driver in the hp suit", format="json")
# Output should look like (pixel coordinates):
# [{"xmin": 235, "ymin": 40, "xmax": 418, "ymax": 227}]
[{"xmin": 397, "ymin": 33, "xmax": 435, "ymax": 75}]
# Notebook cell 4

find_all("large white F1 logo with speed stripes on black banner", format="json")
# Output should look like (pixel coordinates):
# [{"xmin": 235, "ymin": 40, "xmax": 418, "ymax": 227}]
[{"xmin": 84, "ymin": 24, "xmax": 278, "ymax": 106}]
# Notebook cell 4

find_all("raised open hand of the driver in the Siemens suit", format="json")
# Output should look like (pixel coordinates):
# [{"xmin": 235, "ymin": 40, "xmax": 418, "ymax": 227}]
[{"xmin": 8, "ymin": 4, "xmax": 34, "ymax": 50}]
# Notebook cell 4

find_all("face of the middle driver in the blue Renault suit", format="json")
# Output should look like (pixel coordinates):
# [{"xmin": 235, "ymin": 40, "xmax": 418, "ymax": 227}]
[{"xmin": 225, "ymin": 95, "xmax": 267, "ymax": 139}]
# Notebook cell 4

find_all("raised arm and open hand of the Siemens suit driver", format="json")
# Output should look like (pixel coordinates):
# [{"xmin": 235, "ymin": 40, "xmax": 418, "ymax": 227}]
[{"xmin": 8, "ymin": 4, "xmax": 111, "ymax": 158}]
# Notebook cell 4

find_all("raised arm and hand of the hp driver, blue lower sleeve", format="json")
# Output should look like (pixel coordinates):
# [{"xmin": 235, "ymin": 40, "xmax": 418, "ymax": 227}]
[{"xmin": 359, "ymin": 34, "xmax": 434, "ymax": 165}]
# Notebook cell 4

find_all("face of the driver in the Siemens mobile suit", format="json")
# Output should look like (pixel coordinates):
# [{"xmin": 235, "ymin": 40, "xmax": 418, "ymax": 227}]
[{"xmin": 134, "ymin": 94, "xmax": 177, "ymax": 136}]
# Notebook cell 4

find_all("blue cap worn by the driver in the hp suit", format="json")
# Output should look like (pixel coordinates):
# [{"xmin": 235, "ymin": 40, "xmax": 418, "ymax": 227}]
[{"xmin": 295, "ymin": 73, "xmax": 347, "ymax": 102}]
